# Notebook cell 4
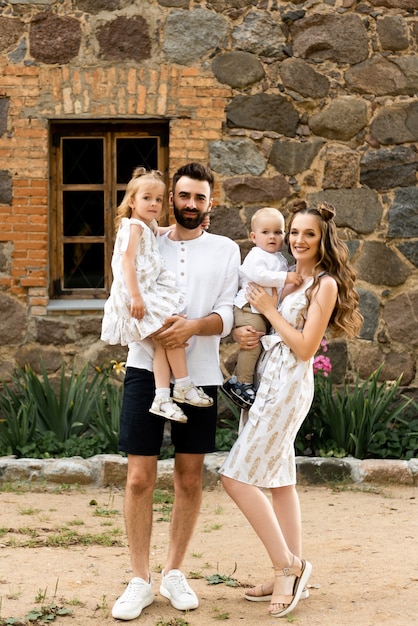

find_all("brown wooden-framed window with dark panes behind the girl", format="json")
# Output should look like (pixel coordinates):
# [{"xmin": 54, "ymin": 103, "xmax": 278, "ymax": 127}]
[{"xmin": 50, "ymin": 121, "xmax": 168, "ymax": 299}]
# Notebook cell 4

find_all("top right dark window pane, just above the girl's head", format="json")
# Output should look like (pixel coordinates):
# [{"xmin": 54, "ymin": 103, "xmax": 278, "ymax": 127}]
[{"xmin": 116, "ymin": 137, "xmax": 158, "ymax": 184}]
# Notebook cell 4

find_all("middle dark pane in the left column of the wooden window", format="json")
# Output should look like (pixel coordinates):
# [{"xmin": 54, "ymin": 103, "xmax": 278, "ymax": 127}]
[{"xmin": 63, "ymin": 191, "xmax": 104, "ymax": 237}]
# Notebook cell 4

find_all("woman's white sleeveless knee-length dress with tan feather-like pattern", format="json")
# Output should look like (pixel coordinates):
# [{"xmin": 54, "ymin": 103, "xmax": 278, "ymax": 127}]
[{"xmin": 220, "ymin": 280, "xmax": 314, "ymax": 488}]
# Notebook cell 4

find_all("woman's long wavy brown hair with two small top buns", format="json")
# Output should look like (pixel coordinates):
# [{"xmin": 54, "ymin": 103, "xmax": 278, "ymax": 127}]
[{"xmin": 285, "ymin": 200, "xmax": 363, "ymax": 337}]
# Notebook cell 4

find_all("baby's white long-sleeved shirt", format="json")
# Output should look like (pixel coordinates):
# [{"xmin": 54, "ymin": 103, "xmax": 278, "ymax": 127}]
[{"xmin": 234, "ymin": 246, "xmax": 288, "ymax": 313}]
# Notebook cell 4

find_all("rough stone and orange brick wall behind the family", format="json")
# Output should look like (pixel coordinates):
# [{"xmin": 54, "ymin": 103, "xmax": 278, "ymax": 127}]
[{"xmin": 0, "ymin": 0, "xmax": 418, "ymax": 388}]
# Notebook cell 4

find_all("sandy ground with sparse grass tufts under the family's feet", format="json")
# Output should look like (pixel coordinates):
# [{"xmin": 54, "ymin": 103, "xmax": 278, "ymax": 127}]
[{"xmin": 0, "ymin": 485, "xmax": 418, "ymax": 626}]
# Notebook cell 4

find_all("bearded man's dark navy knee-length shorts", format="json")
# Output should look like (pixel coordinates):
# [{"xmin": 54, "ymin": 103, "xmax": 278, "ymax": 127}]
[{"xmin": 119, "ymin": 367, "xmax": 217, "ymax": 456}]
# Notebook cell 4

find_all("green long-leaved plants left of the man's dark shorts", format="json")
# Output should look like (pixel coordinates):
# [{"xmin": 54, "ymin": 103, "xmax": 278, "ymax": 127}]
[{"xmin": 0, "ymin": 362, "xmax": 123, "ymax": 458}]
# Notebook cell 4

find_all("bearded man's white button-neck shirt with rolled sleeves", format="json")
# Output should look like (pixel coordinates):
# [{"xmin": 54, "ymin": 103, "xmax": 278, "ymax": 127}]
[{"xmin": 126, "ymin": 231, "xmax": 241, "ymax": 385}]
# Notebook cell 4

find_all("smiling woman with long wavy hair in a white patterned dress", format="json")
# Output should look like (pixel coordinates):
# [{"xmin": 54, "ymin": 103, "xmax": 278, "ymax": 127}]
[{"xmin": 220, "ymin": 202, "xmax": 363, "ymax": 617}]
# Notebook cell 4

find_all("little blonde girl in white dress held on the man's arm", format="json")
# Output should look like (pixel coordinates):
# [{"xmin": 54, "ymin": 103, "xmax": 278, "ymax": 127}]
[{"xmin": 101, "ymin": 167, "xmax": 213, "ymax": 422}]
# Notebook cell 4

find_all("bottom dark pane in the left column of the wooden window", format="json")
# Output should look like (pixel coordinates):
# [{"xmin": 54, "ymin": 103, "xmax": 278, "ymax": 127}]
[{"xmin": 64, "ymin": 243, "xmax": 104, "ymax": 289}]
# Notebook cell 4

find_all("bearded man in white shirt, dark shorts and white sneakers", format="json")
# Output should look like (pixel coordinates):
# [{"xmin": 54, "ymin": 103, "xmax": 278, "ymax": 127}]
[{"xmin": 112, "ymin": 163, "xmax": 240, "ymax": 620}]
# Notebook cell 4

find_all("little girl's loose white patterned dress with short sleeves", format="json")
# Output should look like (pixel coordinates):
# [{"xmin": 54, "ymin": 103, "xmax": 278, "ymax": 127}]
[{"xmin": 101, "ymin": 217, "xmax": 184, "ymax": 346}]
